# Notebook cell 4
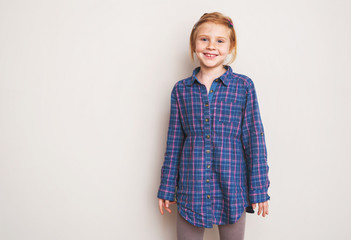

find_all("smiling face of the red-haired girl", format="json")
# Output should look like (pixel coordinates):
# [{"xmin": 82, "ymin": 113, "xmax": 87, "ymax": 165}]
[{"xmin": 195, "ymin": 22, "xmax": 231, "ymax": 71}]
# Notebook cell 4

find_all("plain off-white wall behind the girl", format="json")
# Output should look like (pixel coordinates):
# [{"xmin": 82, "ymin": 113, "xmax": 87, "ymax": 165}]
[{"xmin": 0, "ymin": 0, "xmax": 351, "ymax": 240}]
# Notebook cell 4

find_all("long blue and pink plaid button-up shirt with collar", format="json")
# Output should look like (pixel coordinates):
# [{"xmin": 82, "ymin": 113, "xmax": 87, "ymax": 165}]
[{"xmin": 157, "ymin": 65, "xmax": 270, "ymax": 228}]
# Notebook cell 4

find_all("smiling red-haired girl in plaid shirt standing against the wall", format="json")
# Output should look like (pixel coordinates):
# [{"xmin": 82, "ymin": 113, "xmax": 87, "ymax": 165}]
[{"xmin": 157, "ymin": 12, "xmax": 270, "ymax": 240}]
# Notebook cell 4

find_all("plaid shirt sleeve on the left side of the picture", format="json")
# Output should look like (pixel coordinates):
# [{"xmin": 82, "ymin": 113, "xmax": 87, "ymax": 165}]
[{"xmin": 157, "ymin": 87, "xmax": 185, "ymax": 201}]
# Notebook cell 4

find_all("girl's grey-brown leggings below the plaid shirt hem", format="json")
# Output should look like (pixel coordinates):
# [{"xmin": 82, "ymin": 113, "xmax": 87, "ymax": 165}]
[{"xmin": 177, "ymin": 208, "xmax": 246, "ymax": 240}]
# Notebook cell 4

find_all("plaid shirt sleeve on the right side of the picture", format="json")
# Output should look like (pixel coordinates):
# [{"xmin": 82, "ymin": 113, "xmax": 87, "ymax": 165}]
[{"xmin": 241, "ymin": 80, "xmax": 270, "ymax": 203}]
